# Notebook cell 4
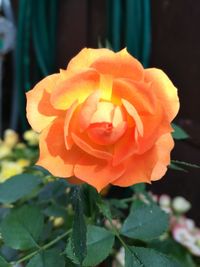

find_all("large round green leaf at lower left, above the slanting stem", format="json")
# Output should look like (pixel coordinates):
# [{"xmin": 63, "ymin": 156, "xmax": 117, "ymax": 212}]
[{"xmin": 1, "ymin": 206, "xmax": 44, "ymax": 250}]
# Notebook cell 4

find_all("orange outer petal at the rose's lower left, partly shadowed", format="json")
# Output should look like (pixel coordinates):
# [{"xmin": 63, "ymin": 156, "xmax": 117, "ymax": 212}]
[{"xmin": 36, "ymin": 119, "xmax": 82, "ymax": 177}]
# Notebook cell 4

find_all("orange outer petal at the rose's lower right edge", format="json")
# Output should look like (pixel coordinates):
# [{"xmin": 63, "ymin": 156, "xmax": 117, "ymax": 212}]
[{"xmin": 112, "ymin": 134, "xmax": 174, "ymax": 186}]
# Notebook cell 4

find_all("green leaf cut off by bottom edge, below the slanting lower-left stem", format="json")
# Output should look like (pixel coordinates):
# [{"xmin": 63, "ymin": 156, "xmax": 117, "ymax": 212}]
[{"xmin": 26, "ymin": 249, "xmax": 65, "ymax": 267}]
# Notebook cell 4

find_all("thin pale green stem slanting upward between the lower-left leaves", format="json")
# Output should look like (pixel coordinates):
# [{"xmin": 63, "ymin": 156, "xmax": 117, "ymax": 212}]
[{"xmin": 11, "ymin": 229, "xmax": 72, "ymax": 265}]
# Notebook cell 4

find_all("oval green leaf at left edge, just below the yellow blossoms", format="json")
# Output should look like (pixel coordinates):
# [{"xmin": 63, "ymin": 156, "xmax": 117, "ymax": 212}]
[{"xmin": 0, "ymin": 174, "xmax": 41, "ymax": 203}]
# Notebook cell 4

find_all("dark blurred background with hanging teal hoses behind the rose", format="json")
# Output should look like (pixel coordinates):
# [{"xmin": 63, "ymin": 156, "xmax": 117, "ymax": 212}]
[{"xmin": 0, "ymin": 0, "xmax": 200, "ymax": 224}]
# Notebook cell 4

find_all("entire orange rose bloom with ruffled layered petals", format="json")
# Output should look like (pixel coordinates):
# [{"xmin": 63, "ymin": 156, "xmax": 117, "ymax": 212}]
[{"xmin": 27, "ymin": 48, "xmax": 179, "ymax": 191}]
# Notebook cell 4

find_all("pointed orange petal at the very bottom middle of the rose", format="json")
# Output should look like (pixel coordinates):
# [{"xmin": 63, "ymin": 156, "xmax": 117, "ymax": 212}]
[{"xmin": 74, "ymin": 155, "xmax": 125, "ymax": 192}]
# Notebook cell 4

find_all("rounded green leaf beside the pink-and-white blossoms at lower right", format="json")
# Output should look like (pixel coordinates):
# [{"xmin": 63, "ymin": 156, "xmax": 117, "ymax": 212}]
[{"xmin": 121, "ymin": 204, "xmax": 169, "ymax": 241}]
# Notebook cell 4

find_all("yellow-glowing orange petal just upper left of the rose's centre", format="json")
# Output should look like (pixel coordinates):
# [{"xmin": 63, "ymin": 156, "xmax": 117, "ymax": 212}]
[{"xmin": 51, "ymin": 69, "xmax": 100, "ymax": 110}]
